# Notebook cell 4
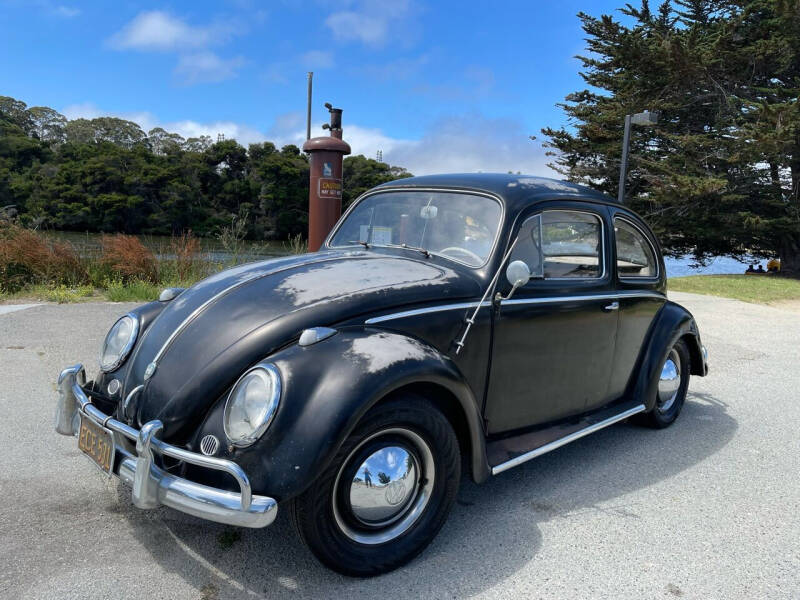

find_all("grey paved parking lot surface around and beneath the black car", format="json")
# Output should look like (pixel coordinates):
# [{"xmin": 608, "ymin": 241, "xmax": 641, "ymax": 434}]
[{"xmin": 0, "ymin": 294, "xmax": 800, "ymax": 600}]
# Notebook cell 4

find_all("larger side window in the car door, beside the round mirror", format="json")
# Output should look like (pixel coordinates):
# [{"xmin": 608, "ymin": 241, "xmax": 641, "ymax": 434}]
[{"xmin": 510, "ymin": 210, "xmax": 603, "ymax": 279}]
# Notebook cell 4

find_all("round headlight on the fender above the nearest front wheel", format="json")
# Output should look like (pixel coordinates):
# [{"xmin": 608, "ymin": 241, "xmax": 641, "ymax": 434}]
[{"xmin": 223, "ymin": 363, "xmax": 281, "ymax": 447}]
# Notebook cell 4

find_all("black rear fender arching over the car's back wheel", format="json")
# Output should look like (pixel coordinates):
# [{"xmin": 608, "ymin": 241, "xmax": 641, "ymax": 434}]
[{"xmin": 631, "ymin": 301, "xmax": 706, "ymax": 411}]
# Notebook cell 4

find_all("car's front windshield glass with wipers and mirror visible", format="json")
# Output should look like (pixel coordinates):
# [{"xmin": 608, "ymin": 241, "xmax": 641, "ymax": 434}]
[{"xmin": 330, "ymin": 191, "xmax": 502, "ymax": 267}]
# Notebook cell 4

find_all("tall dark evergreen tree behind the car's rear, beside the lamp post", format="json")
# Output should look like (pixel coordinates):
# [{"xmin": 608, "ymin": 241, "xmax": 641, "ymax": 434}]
[{"xmin": 543, "ymin": 0, "xmax": 800, "ymax": 273}]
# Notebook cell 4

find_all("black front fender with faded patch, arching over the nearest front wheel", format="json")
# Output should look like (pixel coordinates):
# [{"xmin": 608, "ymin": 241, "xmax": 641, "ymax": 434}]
[{"xmin": 195, "ymin": 327, "xmax": 489, "ymax": 501}]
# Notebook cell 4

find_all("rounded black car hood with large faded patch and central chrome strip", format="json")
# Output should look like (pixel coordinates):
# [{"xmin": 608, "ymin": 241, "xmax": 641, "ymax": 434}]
[{"xmin": 124, "ymin": 251, "xmax": 480, "ymax": 437}]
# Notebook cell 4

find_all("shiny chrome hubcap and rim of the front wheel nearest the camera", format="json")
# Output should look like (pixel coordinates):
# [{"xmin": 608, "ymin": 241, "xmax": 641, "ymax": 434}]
[{"xmin": 333, "ymin": 427, "xmax": 435, "ymax": 544}]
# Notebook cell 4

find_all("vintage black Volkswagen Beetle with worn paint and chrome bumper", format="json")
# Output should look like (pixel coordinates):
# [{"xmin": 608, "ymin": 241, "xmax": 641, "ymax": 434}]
[{"xmin": 56, "ymin": 174, "xmax": 708, "ymax": 576}]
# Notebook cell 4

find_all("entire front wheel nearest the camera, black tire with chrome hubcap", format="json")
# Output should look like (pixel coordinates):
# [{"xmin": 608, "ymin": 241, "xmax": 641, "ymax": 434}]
[{"xmin": 290, "ymin": 395, "xmax": 461, "ymax": 577}]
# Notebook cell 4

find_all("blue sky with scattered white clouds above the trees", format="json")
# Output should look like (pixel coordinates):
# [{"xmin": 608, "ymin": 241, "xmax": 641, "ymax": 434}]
[{"xmin": 0, "ymin": 0, "xmax": 621, "ymax": 175}]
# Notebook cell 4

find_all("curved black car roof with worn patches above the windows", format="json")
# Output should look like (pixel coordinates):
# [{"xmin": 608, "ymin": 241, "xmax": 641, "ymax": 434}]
[{"xmin": 375, "ymin": 173, "xmax": 619, "ymax": 212}]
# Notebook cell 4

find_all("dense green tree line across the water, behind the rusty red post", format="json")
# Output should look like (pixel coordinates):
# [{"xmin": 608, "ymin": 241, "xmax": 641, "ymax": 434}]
[{"xmin": 0, "ymin": 96, "xmax": 409, "ymax": 239}]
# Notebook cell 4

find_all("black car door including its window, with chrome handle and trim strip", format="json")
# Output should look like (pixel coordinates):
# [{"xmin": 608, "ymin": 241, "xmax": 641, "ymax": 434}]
[{"xmin": 486, "ymin": 203, "xmax": 619, "ymax": 434}]
